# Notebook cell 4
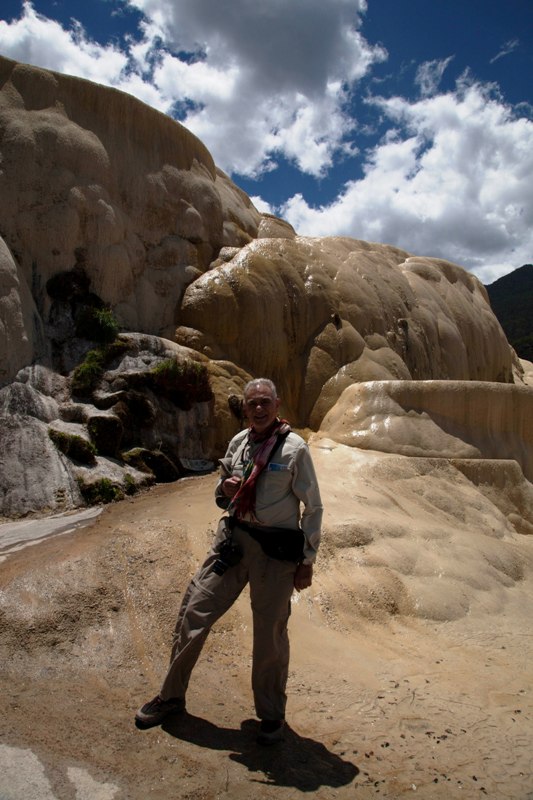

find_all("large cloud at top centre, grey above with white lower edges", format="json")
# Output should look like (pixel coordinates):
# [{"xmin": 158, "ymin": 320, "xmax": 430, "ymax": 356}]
[{"xmin": 123, "ymin": 0, "xmax": 385, "ymax": 176}]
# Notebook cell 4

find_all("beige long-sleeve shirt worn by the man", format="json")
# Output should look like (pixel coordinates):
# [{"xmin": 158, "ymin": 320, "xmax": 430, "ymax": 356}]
[{"xmin": 215, "ymin": 430, "xmax": 322, "ymax": 564}]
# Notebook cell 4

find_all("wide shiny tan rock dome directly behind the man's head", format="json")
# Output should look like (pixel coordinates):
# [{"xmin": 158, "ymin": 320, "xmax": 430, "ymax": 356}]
[{"xmin": 176, "ymin": 237, "xmax": 513, "ymax": 429}]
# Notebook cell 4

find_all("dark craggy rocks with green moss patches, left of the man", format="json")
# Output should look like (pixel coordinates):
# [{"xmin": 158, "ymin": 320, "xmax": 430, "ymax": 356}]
[{"xmin": 0, "ymin": 334, "xmax": 237, "ymax": 517}]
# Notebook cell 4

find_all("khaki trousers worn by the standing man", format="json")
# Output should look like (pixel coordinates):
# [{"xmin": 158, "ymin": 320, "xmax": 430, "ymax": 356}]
[{"xmin": 160, "ymin": 519, "xmax": 296, "ymax": 720}]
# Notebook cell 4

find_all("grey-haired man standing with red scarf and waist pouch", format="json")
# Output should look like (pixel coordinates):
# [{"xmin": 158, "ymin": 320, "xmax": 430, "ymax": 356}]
[{"xmin": 135, "ymin": 378, "xmax": 322, "ymax": 744}]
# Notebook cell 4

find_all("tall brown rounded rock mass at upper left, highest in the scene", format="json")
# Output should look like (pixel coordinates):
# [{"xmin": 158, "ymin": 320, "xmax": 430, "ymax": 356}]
[{"xmin": 0, "ymin": 58, "xmax": 261, "ymax": 378}]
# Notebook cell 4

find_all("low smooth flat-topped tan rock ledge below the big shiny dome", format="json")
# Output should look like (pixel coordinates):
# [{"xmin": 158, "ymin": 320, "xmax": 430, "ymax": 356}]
[{"xmin": 316, "ymin": 380, "xmax": 533, "ymax": 482}]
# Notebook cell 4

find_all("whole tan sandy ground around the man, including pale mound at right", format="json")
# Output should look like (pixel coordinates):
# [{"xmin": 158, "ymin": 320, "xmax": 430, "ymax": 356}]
[{"xmin": 0, "ymin": 439, "xmax": 533, "ymax": 800}]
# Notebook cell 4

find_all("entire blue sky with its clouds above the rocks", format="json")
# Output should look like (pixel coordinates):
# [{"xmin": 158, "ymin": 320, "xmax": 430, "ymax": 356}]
[{"xmin": 0, "ymin": 0, "xmax": 533, "ymax": 283}]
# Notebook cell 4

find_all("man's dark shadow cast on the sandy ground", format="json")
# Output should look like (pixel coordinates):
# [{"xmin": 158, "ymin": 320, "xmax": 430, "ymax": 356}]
[{"xmin": 161, "ymin": 713, "xmax": 359, "ymax": 792}]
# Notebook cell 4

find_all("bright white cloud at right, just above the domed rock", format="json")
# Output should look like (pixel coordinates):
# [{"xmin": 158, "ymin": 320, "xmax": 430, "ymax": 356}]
[{"xmin": 281, "ymin": 84, "xmax": 533, "ymax": 283}]
